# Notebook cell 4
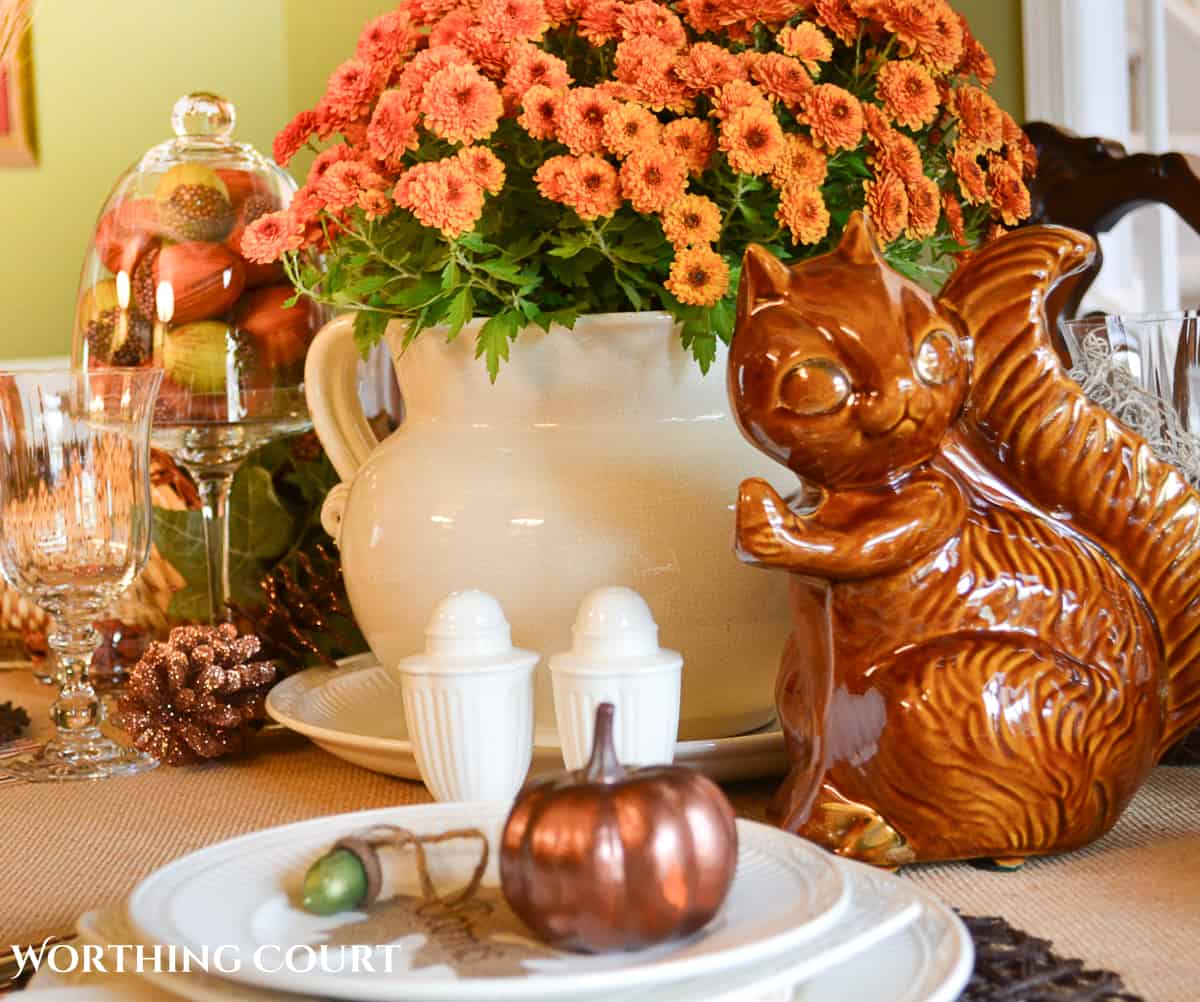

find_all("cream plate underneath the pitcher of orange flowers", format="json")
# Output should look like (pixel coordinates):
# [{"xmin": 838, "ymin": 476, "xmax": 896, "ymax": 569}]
[{"xmin": 266, "ymin": 654, "xmax": 787, "ymax": 782}]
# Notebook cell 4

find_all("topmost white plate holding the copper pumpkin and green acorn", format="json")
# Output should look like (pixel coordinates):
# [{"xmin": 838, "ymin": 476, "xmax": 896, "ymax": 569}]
[{"xmin": 128, "ymin": 803, "xmax": 850, "ymax": 1002}]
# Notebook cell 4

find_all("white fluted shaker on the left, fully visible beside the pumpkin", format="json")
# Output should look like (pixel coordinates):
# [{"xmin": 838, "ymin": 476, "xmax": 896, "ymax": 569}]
[{"xmin": 396, "ymin": 590, "xmax": 538, "ymax": 800}]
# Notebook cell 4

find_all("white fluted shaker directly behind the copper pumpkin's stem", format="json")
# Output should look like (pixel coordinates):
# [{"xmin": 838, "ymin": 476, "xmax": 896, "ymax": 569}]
[{"xmin": 550, "ymin": 587, "xmax": 683, "ymax": 769}]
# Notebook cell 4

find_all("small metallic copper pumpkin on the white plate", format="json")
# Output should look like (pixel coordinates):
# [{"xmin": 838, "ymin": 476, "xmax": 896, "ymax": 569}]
[{"xmin": 500, "ymin": 703, "xmax": 738, "ymax": 953}]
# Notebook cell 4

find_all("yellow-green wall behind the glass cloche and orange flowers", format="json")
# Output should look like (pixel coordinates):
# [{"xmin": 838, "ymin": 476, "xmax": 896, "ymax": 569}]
[{"xmin": 0, "ymin": 0, "xmax": 1022, "ymax": 359}]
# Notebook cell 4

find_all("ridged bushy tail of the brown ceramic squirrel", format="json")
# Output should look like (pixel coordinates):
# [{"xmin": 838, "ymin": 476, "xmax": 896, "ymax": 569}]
[{"xmin": 940, "ymin": 227, "xmax": 1200, "ymax": 752}]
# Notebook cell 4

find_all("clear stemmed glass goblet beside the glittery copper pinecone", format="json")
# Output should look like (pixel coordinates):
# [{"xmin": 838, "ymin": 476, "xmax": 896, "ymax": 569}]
[{"xmin": 0, "ymin": 368, "xmax": 162, "ymax": 780}]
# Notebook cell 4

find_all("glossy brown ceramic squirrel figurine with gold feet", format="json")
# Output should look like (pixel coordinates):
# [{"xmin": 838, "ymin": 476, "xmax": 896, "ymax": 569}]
[{"xmin": 730, "ymin": 216, "xmax": 1200, "ymax": 865}]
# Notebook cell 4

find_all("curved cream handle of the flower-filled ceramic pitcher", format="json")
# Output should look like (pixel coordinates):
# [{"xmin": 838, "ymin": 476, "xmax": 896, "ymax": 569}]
[{"xmin": 304, "ymin": 313, "xmax": 379, "ymax": 484}]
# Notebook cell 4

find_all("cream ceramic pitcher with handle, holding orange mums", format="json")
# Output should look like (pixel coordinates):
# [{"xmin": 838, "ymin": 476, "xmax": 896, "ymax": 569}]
[{"xmin": 305, "ymin": 313, "xmax": 794, "ymax": 743}]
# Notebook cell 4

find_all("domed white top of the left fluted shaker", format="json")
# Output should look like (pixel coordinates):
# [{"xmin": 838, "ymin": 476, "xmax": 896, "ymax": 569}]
[{"xmin": 400, "ymin": 589, "xmax": 538, "ymax": 674}]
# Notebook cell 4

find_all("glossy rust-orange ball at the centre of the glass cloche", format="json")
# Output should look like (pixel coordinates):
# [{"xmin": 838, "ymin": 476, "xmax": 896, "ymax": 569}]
[{"xmin": 154, "ymin": 240, "xmax": 246, "ymax": 324}]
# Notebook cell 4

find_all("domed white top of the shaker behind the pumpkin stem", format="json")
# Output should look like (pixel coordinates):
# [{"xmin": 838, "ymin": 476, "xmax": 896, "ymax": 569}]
[{"xmin": 550, "ymin": 586, "xmax": 683, "ymax": 674}]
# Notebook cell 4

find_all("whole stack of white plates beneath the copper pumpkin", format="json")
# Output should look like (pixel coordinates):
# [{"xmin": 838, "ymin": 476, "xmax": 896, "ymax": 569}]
[{"xmin": 65, "ymin": 804, "xmax": 972, "ymax": 1002}]
